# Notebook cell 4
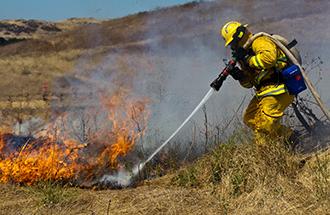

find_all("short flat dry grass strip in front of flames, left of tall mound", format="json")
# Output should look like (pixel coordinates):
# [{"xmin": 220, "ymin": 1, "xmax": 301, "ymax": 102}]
[{"xmin": 0, "ymin": 184, "xmax": 221, "ymax": 214}]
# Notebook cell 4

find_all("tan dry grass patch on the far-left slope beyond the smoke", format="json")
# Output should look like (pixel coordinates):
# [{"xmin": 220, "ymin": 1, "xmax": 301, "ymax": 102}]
[{"xmin": 0, "ymin": 50, "xmax": 81, "ymax": 97}]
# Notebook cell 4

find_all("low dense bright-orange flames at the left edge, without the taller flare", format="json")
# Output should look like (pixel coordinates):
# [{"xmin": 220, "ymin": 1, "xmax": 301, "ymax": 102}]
[{"xmin": 0, "ymin": 139, "xmax": 79, "ymax": 185}]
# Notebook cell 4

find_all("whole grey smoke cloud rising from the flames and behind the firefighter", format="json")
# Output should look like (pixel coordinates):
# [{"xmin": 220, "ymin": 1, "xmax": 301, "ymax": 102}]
[{"xmin": 5, "ymin": 0, "xmax": 330, "ymax": 187}]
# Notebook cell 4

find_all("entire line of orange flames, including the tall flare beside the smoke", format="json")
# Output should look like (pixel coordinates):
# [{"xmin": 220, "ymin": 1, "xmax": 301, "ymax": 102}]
[{"xmin": 0, "ymin": 90, "xmax": 148, "ymax": 185}]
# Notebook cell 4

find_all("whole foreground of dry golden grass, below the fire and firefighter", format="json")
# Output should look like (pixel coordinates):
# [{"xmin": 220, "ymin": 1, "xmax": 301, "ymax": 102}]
[{"xmin": 0, "ymin": 136, "xmax": 330, "ymax": 214}]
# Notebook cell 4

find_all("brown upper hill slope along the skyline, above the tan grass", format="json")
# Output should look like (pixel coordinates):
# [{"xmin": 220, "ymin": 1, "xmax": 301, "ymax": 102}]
[{"xmin": 0, "ymin": 0, "xmax": 330, "ymax": 56}]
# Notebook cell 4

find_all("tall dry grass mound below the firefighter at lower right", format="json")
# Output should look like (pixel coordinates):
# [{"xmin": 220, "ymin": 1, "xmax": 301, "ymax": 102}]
[{"xmin": 172, "ymin": 129, "xmax": 330, "ymax": 214}]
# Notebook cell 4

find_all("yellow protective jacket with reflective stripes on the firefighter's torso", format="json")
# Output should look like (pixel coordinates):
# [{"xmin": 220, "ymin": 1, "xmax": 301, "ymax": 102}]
[{"xmin": 240, "ymin": 36, "xmax": 287, "ymax": 97}]
